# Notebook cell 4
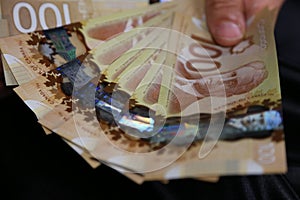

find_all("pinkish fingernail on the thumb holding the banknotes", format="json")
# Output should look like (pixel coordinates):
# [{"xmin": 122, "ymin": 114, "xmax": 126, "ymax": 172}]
[{"xmin": 215, "ymin": 22, "xmax": 243, "ymax": 40}]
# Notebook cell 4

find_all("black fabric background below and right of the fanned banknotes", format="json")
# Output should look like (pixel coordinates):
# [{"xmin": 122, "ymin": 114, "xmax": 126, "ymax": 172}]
[{"xmin": 0, "ymin": 0, "xmax": 300, "ymax": 200}]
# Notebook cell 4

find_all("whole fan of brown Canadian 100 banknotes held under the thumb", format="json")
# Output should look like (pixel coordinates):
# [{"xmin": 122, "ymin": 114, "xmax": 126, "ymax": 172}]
[{"xmin": 0, "ymin": 0, "xmax": 286, "ymax": 183}]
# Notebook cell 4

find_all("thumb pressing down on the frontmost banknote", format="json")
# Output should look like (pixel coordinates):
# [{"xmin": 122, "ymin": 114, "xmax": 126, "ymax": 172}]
[{"xmin": 205, "ymin": 0, "xmax": 245, "ymax": 46}]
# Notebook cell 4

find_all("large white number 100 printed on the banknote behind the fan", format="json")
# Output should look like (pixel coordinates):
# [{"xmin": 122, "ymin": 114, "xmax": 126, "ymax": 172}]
[{"xmin": 13, "ymin": 2, "xmax": 71, "ymax": 33}]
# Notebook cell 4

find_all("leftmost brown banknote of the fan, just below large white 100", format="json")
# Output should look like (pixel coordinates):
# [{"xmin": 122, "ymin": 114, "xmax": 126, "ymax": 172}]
[{"xmin": 0, "ymin": 0, "xmax": 174, "ymax": 85}]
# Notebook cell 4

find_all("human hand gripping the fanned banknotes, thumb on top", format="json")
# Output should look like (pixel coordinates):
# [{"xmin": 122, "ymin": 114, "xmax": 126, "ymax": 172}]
[{"xmin": 205, "ymin": 0, "xmax": 284, "ymax": 46}]
